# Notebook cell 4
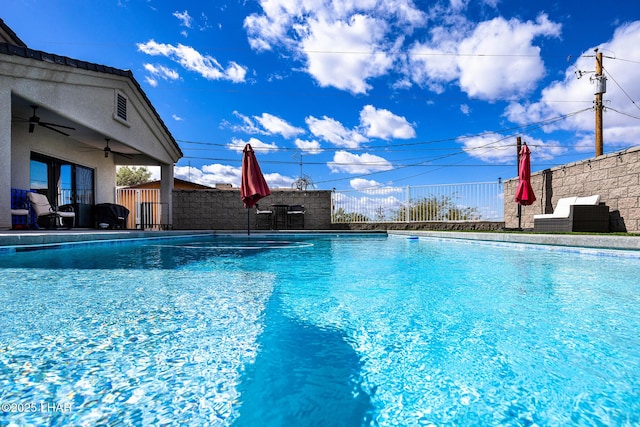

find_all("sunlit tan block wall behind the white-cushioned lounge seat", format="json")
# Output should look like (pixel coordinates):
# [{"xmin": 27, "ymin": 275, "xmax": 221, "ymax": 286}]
[{"xmin": 504, "ymin": 147, "xmax": 640, "ymax": 233}]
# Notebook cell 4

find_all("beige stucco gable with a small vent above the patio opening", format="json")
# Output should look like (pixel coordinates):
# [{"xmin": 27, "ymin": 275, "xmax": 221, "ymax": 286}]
[{"xmin": 0, "ymin": 55, "xmax": 180, "ymax": 165}]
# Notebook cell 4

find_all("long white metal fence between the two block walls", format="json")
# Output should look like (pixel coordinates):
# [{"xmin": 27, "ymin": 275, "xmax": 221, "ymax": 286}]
[{"xmin": 331, "ymin": 182, "xmax": 504, "ymax": 223}]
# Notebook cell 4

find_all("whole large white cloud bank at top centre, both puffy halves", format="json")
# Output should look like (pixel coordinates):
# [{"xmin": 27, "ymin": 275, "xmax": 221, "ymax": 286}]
[{"xmin": 244, "ymin": 0, "xmax": 561, "ymax": 101}]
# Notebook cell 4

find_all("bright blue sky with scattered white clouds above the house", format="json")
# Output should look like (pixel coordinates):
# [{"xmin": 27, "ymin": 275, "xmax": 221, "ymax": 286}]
[{"xmin": 1, "ymin": 0, "xmax": 640, "ymax": 189}]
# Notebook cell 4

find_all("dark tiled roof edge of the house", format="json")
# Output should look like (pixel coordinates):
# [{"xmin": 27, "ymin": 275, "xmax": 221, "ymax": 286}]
[{"xmin": 0, "ymin": 19, "xmax": 183, "ymax": 157}]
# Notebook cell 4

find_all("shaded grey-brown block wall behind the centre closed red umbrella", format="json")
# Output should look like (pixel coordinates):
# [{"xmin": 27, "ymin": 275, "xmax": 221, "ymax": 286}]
[{"xmin": 173, "ymin": 189, "xmax": 331, "ymax": 230}]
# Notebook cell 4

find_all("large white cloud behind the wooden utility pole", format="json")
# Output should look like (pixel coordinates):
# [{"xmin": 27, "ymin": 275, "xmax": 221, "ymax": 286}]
[{"xmin": 505, "ymin": 21, "xmax": 640, "ymax": 151}]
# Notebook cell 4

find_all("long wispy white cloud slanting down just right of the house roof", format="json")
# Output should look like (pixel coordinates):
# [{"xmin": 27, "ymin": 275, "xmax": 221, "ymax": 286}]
[{"xmin": 137, "ymin": 40, "xmax": 247, "ymax": 83}]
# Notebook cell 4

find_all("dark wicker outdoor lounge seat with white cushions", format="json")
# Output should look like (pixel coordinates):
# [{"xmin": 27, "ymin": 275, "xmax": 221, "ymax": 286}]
[{"xmin": 533, "ymin": 195, "xmax": 609, "ymax": 233}]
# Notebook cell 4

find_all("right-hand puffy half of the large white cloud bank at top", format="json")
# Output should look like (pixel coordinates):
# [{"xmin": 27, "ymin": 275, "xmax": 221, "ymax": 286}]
[{"xmin": 409, "ymin": 14, "xmax": 561, "ymax": 101}]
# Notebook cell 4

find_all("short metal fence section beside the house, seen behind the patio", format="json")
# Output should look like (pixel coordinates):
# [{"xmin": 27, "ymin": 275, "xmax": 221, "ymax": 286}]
[{"xmin": 116, "ymin": 188, "xmax": 168, "ymax": 230}]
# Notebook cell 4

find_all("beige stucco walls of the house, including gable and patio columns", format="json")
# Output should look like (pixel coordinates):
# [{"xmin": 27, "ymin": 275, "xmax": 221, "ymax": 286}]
[{"xmin": 0, "ymin": 45, "xmax": 182, "ymax": 229}]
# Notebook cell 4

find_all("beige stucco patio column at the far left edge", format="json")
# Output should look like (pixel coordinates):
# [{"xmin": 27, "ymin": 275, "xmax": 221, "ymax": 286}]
[{"xmin": 0, "ymin": 89, "xmax": 11, "ymax": 230}]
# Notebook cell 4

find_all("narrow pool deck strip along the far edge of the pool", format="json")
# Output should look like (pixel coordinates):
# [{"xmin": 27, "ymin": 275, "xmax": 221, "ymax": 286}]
[{"xmin": 0, "ymin": 229, "xmax": 640, "ymax": 250}]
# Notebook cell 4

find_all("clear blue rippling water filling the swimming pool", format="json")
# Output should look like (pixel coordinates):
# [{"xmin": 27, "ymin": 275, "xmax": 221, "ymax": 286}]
[{"xmin": 0, "ymin": 236, "xmax": 640, "ymax": 426}]
